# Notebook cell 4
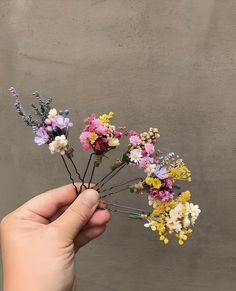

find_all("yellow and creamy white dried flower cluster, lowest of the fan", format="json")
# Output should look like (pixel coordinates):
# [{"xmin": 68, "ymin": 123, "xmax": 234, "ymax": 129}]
[{"xmin": 144, "ymin": 191, "xmax": 201, "ymax": 245}]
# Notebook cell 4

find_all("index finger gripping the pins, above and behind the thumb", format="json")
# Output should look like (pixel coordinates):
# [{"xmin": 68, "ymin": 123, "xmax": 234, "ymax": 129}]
[{"xmin": 19, "ymin": 183, "xmax": 83, "ymax": 218}]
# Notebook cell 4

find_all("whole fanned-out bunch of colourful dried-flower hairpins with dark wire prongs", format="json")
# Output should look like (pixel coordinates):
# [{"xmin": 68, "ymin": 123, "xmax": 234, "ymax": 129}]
[{"xmin": 9, "ymin": 87, "xmax": 201, "ymax": 245}]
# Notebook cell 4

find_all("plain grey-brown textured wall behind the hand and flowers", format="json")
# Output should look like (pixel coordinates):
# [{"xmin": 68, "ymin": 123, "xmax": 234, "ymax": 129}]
[{"xmin": 0, "ymin": 0, "xmax": 236, "ymax": 291}]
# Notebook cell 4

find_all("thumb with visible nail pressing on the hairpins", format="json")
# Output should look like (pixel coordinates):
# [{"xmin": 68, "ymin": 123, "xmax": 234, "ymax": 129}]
[{"xmin": 53, "ymin": 189, "xmax": 100, "ymax": 240}]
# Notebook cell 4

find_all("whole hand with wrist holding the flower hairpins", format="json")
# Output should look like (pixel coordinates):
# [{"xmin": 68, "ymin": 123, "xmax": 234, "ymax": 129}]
[{"xmin": 1, "ymin": 185, "xmax": 110, "ymax": 291}]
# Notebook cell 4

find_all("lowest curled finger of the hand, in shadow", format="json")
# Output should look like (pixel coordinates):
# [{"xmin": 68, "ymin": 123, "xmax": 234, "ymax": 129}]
[{"xmin": 74, "ymin": 225, "xmax": 106, "ymax": 251}]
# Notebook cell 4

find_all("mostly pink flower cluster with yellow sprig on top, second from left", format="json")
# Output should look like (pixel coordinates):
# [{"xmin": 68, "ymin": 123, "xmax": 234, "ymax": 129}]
[{"xmin": 80, "ymin": 112, "xmax": 122, "ymax": 155}]
